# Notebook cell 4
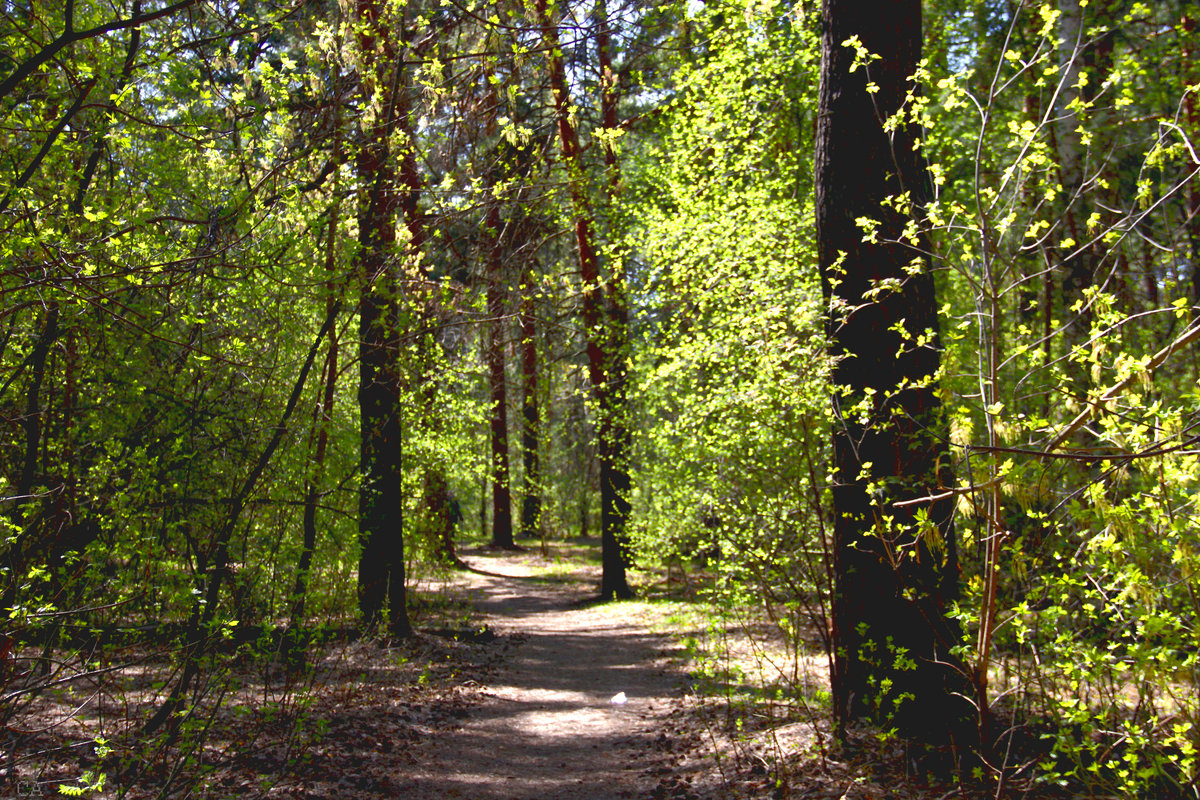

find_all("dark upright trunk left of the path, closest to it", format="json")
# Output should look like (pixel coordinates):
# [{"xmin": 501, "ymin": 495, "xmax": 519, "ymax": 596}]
[{"xmin": 356, "ymin": 0, "xmax": 413, "ymax": 637}]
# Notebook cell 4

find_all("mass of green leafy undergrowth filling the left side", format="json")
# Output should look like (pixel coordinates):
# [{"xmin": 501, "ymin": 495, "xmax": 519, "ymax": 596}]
[{"xmin": 0, "ymin": 4, "xmax": 367, "ymax": 657}]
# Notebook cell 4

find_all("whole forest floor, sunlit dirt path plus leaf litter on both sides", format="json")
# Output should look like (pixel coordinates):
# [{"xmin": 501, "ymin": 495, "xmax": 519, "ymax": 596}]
[{"xmin": 9, "ymin": 542, "xmax": 969, "ymax": 800}]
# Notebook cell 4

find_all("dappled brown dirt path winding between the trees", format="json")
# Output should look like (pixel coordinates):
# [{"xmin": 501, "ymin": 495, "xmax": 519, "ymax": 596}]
[{"xmin": 396, "ymin": 544, "xmax": 691, "ymax": 800}]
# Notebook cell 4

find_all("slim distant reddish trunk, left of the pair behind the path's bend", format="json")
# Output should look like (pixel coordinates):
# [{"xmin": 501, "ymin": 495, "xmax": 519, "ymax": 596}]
[{"xmin": 487, "ymin": 199, "xmax": 514, "ymax": 549}]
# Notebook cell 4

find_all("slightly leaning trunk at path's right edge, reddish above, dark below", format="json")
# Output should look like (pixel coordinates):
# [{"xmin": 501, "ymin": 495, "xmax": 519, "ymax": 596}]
[{"xmin": 538, "ymin": 0, "xmax": 634, "ymax": 600}]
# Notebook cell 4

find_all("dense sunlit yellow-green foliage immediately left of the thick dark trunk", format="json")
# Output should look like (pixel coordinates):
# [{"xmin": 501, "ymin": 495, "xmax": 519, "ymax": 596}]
[{"xmin": 626, "ymin": 4, "xmax": 827, "ymax": 633}]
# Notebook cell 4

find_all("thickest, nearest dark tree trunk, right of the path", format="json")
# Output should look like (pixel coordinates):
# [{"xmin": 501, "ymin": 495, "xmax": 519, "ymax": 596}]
[{"xmin": 816, "ymin": 0, "xmax": 974, "ymax": 747}]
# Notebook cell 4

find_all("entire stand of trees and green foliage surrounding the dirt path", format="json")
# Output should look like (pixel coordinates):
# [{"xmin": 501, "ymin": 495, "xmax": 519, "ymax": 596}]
[{"xmin": 0, "ymin": 0, "xmax": 1200, "ymax": 796}]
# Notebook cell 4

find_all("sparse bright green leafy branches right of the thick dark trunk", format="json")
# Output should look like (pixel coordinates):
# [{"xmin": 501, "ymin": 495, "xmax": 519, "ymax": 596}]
[{"xmin": 923, "ymin": 1, "xmax": 1200, "ymax": 796}]
